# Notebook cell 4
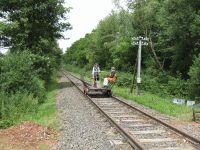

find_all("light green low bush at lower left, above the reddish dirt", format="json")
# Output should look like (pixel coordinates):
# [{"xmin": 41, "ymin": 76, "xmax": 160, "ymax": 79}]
[{"xmin": 0, "ymin": 92, "xmax": 38, "ymax": 128}]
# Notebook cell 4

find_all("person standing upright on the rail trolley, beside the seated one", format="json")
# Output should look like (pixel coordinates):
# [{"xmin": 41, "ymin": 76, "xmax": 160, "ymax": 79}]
[{"xmin": 92, "ymin": 63, "xmax": 100, "ymax": 87}]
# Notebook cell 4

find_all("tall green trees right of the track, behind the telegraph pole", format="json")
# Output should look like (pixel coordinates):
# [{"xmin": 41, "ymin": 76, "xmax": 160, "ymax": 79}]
[{"xmin": 64, "ymin": 0, "xmax": 200, "ymax": 100}]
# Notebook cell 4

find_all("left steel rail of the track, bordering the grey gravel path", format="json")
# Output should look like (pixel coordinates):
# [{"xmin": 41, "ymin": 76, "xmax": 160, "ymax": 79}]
[{"xmin": 63, "ymin": 72, "xmax": 145, "ymax": 150}]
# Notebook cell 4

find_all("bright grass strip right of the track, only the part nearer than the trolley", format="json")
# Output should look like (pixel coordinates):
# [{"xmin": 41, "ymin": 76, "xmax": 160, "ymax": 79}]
[{"xmin": 112, "ymin": 87, "xmax": 192, "ymax": 120}]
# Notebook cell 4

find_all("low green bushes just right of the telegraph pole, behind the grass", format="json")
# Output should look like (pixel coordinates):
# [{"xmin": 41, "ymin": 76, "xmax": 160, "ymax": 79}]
[{"xmin": 141, "ymin": 69, "xmax": 188, "ymax": 98}]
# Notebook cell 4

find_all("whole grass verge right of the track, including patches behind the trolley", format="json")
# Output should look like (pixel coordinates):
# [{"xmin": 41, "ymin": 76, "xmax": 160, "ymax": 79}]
[{"xmin": 65, "ymin": 65, "xmax": 195, "ymax": 121}]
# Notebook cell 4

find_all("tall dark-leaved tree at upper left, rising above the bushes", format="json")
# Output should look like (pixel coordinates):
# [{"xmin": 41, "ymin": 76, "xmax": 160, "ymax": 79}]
[{"xmin": 0, "ymin": 0, "xmax": 71, "ymax": 81}]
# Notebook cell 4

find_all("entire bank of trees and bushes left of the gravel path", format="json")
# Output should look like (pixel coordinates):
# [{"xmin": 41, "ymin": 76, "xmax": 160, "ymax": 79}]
[{"xmin": 0, "ymin": 0, "xmax": 70, "ymax": 128}]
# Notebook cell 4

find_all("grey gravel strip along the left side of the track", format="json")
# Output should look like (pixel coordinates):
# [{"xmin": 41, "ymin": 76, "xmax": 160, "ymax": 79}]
[{"xmin": 54, "ymin": 77, "xmax": 132, "ymax": 150}]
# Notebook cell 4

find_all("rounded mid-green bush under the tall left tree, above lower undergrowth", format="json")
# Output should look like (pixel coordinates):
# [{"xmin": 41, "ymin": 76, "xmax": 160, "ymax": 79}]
[{"xmin": 0, "ymin": 52, "xmax": 45, "ymax": 102}]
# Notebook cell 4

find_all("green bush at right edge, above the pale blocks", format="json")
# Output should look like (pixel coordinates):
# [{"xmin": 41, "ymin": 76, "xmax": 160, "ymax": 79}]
[{"xmin": 189, "ymin": 54, "xmax": 200, "ymax": 101}]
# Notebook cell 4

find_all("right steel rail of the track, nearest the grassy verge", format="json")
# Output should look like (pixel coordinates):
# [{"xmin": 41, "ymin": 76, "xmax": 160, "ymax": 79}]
[{"xmin": 66, "ymin": 73, "xmax": 200, "ymax": 148}]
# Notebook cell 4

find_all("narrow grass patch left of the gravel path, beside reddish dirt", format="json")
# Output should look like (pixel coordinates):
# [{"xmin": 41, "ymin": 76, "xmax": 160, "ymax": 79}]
[{"xmin": 21, "ymin": 75, "xmax": 59, "ymax": 130}]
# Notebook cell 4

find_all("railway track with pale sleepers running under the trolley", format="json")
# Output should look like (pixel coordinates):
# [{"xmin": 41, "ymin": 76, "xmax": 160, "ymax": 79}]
[{"xmin": 64, "ymin": 73, "xmax": 200, "ymax": 150}]
